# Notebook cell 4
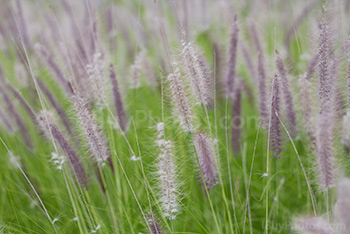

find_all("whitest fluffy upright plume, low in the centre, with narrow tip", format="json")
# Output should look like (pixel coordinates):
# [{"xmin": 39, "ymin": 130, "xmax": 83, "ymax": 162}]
[{"xmin": 156, "ymin": 122, "xmax": 179, "ymax": 220}]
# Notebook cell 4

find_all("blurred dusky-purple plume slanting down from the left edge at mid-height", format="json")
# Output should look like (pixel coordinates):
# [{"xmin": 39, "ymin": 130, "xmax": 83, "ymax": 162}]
[{"xmin": 0, "ymin": 87, "xmax": 32, "ymax": 148}]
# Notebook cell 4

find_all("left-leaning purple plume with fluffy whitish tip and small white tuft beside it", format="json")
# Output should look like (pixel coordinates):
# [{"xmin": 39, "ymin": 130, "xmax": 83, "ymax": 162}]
[{"xmin": 38, "ymin": 111, "xmax": 87, "ymax": 188}]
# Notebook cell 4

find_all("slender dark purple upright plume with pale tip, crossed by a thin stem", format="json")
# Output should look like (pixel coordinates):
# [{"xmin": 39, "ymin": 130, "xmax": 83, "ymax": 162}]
[{"xmin": 270, "ymin": 75, "xmax": 282, "ymax": 157}]
